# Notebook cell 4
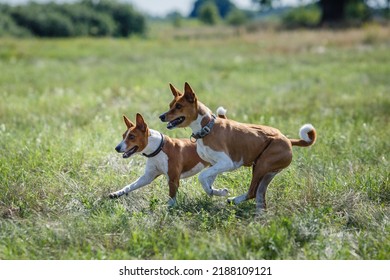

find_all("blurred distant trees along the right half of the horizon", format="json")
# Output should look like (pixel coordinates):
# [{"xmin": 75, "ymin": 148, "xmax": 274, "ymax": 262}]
[{"xmin": 189, "ymin": 0, "xmax": 390, "ymax": 28}]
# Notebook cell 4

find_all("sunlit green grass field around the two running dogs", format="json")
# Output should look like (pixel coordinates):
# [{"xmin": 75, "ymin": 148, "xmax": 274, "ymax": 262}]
[{"xmin": 0, "ymin": 26, "xmax": 390, "ymax": 259}]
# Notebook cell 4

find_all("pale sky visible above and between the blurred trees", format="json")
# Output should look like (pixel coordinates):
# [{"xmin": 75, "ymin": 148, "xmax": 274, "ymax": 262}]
[{"xmin": 0, "ymin": 0, "xmax": 385, "ymax": 17}]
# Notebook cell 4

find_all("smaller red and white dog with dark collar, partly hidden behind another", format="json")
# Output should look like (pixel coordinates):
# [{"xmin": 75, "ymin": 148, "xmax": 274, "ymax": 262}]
[{"xmin": 109, "ymin": 111, "xmax": 225, "ymax": 206}]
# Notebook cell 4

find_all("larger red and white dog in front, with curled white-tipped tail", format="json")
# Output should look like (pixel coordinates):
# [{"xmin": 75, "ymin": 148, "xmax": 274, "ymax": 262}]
[{"xmin": 160, "ymin": 83, "xmax": 316, "ymax": 211}]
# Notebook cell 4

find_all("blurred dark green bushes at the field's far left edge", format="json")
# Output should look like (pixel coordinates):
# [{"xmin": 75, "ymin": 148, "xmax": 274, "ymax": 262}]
[{"xmin": 0, "ymin": 0, "xmax": 146, "ymax": 37}]
